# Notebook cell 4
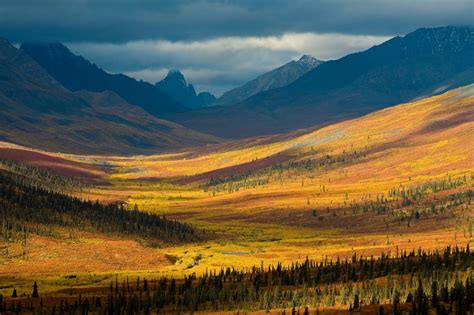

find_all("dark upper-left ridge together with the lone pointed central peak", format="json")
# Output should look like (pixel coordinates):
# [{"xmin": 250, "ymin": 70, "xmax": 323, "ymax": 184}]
[{"xmin": 20, "ymin": 43, "xmax": 215, "ymax": 110}]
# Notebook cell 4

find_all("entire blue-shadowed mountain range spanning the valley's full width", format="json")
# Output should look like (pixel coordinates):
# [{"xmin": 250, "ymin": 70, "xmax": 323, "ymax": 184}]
[{"xmin": 0, "ymin": 26, "xmax": 474, "ymax": 154}]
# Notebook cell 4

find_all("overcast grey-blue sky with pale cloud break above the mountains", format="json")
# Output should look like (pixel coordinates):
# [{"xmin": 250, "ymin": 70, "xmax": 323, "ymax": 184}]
[{"xmin": 0, "ymin": 0, "xmax": 474, "ymax": 95}]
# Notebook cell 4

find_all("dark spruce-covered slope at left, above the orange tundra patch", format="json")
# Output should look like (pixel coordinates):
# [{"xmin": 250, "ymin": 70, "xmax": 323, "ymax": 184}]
[{"xmin": 0, "ymin": 171, "xmax": 203, "ymax": 244}]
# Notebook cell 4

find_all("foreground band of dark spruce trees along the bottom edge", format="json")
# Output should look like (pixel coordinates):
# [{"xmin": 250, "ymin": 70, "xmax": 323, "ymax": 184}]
[{"xmin": 4, "ymin": 246, "xmax": 474, "ymax": 314}]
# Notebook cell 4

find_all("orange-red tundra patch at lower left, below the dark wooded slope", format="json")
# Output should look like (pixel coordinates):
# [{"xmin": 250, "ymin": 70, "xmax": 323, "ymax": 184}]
[{"xmin": 0, "ymin": 229, "xmax": 170, "ymax": 276}]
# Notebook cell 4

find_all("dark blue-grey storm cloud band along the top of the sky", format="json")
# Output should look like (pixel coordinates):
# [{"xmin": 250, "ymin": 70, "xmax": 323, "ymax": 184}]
[{"xmin": 0, "ymin": 0, "xmax": 474, "ymax": 42}]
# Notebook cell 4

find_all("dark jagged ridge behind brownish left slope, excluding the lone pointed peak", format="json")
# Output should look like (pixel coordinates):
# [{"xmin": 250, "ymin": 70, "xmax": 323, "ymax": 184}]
[{"xmin": 20, "ymin": 43, "xmax": 186, "ymax": 117}]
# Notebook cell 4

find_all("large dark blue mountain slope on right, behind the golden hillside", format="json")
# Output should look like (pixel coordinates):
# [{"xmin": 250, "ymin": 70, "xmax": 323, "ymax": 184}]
[{"xmin": 169, "ymin": 26, "xmax": 474, "ymax": 138}]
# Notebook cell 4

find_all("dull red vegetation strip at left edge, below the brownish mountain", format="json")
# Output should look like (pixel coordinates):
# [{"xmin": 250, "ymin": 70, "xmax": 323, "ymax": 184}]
[{"xmin": 0, "ymin": 148, "xmax": 104, "ymax": 179}]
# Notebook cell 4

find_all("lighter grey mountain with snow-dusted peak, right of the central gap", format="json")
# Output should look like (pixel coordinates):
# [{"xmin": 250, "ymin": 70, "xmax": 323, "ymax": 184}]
[{"xmin": 213, "ymin": 55, "xmax": 324, "ymax": 106}]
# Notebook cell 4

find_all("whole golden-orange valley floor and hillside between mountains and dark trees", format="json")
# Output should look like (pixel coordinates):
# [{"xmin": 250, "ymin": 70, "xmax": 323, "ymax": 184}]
[{"xmin": 0, "ymin": 85, "xmax": 474, "ymax": 312}]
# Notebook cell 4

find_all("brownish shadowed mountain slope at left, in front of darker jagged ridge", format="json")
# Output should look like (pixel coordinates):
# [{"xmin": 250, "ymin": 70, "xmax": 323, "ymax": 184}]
[{"xmin": 0, "ymin": 39, "xmax": 218, "ymax": 154}]
